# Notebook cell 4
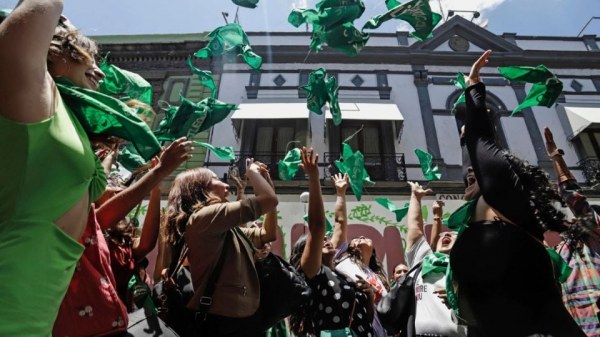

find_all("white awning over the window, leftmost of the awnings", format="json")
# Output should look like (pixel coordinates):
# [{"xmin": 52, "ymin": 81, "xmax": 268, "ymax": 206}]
[{"xmin": 231, "ymin": 102, "xmax": 308, "ymax": 135}]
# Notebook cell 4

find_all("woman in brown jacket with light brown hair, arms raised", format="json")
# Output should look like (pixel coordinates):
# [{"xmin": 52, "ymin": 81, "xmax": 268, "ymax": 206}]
[{"xmin": 166, "ymin": 159, "xmax": 278, "ymax": 336}]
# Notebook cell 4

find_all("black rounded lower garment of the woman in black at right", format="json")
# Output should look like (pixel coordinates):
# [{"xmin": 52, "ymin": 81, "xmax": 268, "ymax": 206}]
[{"xmin": 450, "ymin": 221, "xmax": 585, "ymax": 337}]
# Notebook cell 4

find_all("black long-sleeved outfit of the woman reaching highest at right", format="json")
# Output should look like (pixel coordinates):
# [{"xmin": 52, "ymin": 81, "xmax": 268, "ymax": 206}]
[{"xmin": 450, "ymin": 83, "xmax": 585, "ymax": 337}]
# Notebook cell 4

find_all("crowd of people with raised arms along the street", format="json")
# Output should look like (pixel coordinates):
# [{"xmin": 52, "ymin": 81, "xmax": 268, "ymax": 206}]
[{"xmin": 0, "ymin": 0, "xmax": 600, "ymax": 337}]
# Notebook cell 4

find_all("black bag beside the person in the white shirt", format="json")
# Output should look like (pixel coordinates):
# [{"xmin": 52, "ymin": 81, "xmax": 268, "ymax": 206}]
[{"xmin": 377, "ymin": 263, "xmax": 421, "ymax": 336}]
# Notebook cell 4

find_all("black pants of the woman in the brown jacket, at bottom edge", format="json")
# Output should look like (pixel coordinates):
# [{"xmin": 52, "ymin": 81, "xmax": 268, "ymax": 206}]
[{"xmin": 186, "ymin": 314, "xmax": 265, "ymax": 337}]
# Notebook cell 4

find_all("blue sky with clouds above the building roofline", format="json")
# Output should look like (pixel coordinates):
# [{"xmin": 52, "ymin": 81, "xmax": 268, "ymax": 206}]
[{"xmin": 0, "ymin": 0, "xmax": 600, "ymax": 36}]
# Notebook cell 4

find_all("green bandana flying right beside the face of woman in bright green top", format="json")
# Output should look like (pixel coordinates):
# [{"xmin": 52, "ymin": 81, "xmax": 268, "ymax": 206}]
[{"xmin": 98, "ymin": 55, "xmax": 152, "ymax": 105}]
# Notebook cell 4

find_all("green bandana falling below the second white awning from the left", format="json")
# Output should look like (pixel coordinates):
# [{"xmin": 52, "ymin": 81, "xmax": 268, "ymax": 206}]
[{"xmin": 335, "ymin": 143, "xmax": 375, "ymax": 201}]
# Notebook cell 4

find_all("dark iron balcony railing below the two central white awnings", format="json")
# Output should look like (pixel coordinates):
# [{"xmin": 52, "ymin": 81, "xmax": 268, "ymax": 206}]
[{"xmin": 205, "ymin": 152, "xmax": 406, "ymax": 181}]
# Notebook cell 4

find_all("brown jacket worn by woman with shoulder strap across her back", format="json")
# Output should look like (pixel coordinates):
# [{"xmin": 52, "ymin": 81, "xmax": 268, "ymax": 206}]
[{"xmin": 185, "ymin": 198, "xmax": 262, "ymax": 317}]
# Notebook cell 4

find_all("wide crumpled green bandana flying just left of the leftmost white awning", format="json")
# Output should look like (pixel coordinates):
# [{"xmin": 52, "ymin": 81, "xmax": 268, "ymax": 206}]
[{"xmin": 154, "ymin": 96, "xmax": 237, "ymax": 141}]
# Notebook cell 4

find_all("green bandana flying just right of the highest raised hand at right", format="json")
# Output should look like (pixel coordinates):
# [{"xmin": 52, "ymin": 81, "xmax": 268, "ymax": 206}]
[{"xmin": 498, "ymin": 65, "xmax": 563, "ymax": 116}]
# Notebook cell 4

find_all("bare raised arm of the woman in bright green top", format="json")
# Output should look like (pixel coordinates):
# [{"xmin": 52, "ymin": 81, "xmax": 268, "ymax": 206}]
[{"xmin": 0, "ymin": 0, "xmax": 63, "ymax": 123}]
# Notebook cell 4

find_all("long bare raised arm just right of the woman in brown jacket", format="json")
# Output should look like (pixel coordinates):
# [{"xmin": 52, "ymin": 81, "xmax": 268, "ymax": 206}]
[{"xmin": 300, "ymin": 147, "xmax": 325, "ymax": 279}]
